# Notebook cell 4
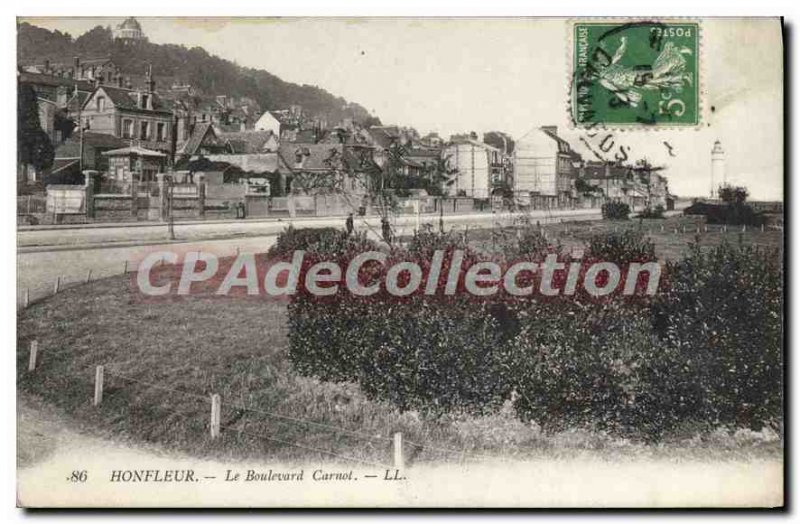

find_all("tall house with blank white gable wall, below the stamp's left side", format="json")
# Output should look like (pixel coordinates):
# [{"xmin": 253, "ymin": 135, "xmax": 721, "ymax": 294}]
[{"xmin": 513, "ymin": 126, "xmax": 581, "ymax": 209}]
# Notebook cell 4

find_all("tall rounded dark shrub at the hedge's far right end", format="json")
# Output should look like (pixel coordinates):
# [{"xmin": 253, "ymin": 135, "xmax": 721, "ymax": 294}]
[{"xmin": 653, "ymin": 243, "xmax": 783, "ymax": 429}]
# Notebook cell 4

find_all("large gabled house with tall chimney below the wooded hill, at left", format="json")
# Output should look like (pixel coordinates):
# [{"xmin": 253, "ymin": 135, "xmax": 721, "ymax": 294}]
[{"xmin": 81, "ymin": 70, "xmax": 173, "ymax": 152}]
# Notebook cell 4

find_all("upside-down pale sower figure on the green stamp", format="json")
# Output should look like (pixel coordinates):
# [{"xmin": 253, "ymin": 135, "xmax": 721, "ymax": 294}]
[{"xmin": 597, "ymin": 36, "xmax": 692, "ymax": 107}]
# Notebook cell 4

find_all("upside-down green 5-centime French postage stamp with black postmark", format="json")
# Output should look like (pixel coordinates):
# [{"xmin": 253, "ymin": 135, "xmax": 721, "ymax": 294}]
[{"xmin": 571, "ymin": 21, "xmax": 700, "ymax": 127}]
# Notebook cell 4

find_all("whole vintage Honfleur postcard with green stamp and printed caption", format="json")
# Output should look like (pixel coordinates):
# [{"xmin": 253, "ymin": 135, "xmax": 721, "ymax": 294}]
[{"xmin": 16, "ymin": 13, "xmax": 786, "ymax": 508}]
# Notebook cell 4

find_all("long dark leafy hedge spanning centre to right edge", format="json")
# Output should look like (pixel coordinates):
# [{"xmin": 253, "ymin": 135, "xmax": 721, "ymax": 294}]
[{"xmin": 289, "ymin": 228, "xmax": 783, "ymax": 439}]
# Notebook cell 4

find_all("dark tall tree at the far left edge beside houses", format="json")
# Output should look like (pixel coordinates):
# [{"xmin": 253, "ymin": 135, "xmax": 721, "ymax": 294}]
[{"xmin": 17, "ymin": 84, "xmax": 55, "ymax": 180}]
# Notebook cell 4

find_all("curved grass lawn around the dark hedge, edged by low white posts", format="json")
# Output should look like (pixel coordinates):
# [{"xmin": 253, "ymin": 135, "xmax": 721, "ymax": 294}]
[{"xmin": 17, "ymin": 219, "xmax": 782, "ymax": 465}]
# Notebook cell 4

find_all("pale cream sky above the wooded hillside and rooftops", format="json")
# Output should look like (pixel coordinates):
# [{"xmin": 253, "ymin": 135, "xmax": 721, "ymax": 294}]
[{"xmin": 23, "ymin": 17, "xmax": 783, "ymax": 200}]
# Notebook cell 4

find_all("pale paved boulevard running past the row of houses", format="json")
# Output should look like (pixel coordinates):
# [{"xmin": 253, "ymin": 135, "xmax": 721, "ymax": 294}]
[{"xmin": 17, "ymin": 210, "xmax": 600, "ymax": 304}]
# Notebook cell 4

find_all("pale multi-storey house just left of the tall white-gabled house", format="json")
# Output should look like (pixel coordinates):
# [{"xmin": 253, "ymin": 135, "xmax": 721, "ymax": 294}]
[{"xmin": 443, "ymin": 138, "xmax": 499, "ymax": 198}]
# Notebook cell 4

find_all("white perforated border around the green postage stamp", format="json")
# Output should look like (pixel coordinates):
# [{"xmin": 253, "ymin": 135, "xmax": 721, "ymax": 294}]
[{"xmin": 564, "ymin": 16, "xmax": 708, "ymax": 132}]
